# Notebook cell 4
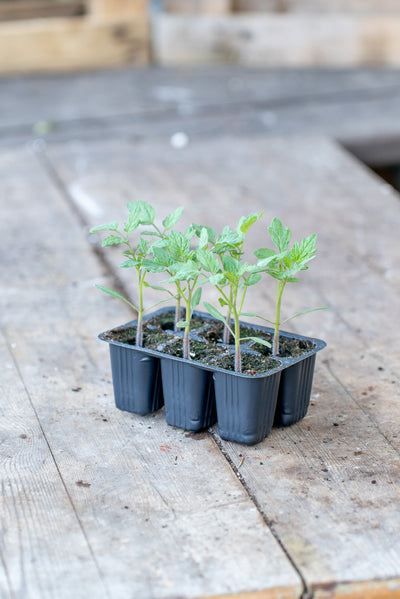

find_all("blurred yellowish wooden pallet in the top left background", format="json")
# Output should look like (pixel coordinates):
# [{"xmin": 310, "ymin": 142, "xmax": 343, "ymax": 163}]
[{"xmin": 0, "ymin": 0, "xmax": 149, "ymax": 74}]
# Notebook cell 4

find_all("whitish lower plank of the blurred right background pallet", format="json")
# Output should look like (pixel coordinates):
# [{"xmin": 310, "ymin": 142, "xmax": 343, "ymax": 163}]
[{"xmin": 153, "ymin": 13, "xmax": 400, "ymax": 67}]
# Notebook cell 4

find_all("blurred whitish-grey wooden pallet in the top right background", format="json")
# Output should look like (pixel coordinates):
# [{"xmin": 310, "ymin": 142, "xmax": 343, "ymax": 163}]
[{"xmin": 152, "ymin": 0, "xmax": 400, "ymax": 67}]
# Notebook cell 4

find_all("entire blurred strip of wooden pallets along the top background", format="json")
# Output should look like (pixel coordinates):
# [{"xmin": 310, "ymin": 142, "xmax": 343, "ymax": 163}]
[{"xmin": 0, "ymin": 0, "xmax": 400, "ymax": 73}]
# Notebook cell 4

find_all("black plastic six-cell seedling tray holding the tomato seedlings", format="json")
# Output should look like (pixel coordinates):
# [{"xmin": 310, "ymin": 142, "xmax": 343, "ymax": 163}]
[{"xmin": 99, "ymin": 308, "xmax": 326, "ymax": 445}]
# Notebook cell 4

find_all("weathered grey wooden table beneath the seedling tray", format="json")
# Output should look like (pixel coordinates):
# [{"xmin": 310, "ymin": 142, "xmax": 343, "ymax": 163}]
[{"xmin": 0, "ymin": 71, "xmax": 400, "ymax": 599}]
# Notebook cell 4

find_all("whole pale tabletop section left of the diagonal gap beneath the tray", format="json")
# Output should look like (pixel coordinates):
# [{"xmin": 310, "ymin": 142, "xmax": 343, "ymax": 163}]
[{"xmin": 1, "ymin": 145, "xmax": 302, "ymax": 599}]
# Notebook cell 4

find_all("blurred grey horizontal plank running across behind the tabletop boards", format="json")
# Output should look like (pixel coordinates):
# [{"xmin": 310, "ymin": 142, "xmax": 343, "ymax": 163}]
[{"xmin": 0, "ymin": 67, "xmax": 400, "ymax": 164}]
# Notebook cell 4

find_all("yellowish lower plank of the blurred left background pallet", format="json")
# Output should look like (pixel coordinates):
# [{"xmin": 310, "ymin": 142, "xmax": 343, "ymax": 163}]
[{"xmin": 0, "ymin": 16, "xmax": 148, "ymax": 74}]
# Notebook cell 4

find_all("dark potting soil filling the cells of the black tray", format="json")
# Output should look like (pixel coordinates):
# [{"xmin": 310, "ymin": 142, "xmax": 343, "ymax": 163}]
[{"xmin": 108, "ymin": 312, "xmax": 314, "ymax": 375}]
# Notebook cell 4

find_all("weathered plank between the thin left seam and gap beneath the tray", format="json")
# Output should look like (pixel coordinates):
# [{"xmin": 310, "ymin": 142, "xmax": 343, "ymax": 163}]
[{"xmin": 0, "ymin": 146, "xmax": 302, "ymax": 599}]
